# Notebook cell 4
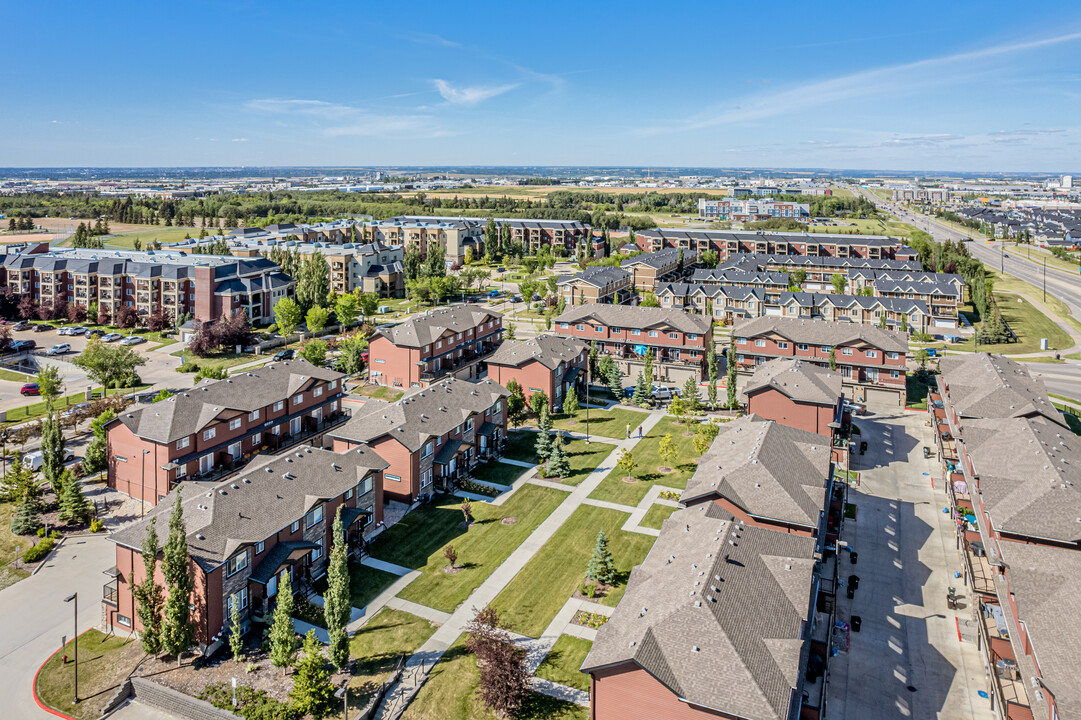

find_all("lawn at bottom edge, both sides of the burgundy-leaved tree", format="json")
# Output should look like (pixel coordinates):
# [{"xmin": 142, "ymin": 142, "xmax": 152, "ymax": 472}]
[{"xmin": 402, "ymin": 636, "xmax": 589, "ymax": 720}]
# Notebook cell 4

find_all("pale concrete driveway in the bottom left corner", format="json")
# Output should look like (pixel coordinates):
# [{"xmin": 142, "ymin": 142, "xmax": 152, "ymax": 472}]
[{"xmin": 0, "ymin": 535, "xmax": 116, "ymax": 719}]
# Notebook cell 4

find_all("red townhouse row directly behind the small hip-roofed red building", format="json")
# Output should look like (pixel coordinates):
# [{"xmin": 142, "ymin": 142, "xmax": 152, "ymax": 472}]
[{"xmin": 732, "ymin": 317, "xmax": 908, "ymax": 406}]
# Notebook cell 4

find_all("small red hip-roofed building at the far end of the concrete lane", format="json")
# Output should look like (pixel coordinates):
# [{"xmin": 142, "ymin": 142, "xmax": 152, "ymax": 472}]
[{"xmin": 740, "ymin": 358, "xmax": 844, "ymax": 439}]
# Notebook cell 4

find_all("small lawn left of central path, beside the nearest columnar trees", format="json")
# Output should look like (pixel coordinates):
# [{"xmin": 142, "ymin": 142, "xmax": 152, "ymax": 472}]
[{"xmin": 350, "ymin": 608, "xmax": 437, "ymax": 710}]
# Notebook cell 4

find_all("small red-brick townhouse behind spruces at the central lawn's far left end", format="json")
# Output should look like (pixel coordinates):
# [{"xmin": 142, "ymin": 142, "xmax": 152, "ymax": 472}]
[{"xmin": 488, "ymin": 335, "xmax": 589, "ymax": 410}]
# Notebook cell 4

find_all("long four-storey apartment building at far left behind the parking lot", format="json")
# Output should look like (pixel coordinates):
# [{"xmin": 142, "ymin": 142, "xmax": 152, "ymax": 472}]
[{"xmin": 0, "ymin": 248, "xmax": 295, "ymax": 323}]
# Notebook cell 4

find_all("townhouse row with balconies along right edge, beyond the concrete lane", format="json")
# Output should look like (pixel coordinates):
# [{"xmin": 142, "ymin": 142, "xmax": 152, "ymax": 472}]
[{"xmin": 929, "ymin": 354, "xmax": 1081, "ymax": 720}]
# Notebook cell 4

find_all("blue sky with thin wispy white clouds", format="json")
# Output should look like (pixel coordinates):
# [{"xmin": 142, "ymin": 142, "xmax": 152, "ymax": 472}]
[{"xmin": 6, "ymin": 0, "xmax": 1081, "ymax": 172}]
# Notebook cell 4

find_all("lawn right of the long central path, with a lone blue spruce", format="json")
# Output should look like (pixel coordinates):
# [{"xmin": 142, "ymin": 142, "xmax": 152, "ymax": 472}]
[{"xmin": 492, "ymin": 505, "xmax": 654, "ymax": 638}]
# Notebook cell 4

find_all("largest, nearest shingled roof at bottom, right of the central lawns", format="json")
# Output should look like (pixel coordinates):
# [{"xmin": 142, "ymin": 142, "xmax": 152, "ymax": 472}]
[{"xmin": 582, "ymin": 503, "xmax": 815, "ymax": 720}]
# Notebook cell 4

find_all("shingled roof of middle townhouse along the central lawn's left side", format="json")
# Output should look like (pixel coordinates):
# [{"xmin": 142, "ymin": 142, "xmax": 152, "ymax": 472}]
[{"xmin": 329, "ymin": 377, "xmax": 510, "ymax": 452}]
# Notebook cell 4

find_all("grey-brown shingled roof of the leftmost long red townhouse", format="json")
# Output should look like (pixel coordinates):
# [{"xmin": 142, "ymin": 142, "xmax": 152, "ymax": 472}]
[{"xmin": 118, "ymin": 360, "xmax": 345, "ymax": 442}]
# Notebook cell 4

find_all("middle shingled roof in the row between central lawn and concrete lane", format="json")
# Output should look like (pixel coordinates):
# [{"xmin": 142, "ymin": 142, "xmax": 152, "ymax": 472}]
[{"xmin": 680, "ymin": 414, "xmax": 830, "ymax": 529}]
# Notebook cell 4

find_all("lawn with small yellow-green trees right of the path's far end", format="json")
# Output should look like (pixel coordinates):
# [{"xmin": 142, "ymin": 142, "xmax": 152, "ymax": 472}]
[{"xmin": 590, "ymin": 417, "xmax": 698, "ymax": 505}]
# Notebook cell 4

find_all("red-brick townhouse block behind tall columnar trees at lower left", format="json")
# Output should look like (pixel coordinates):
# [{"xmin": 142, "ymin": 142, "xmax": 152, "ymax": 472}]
[{"xmin": 102, "ymin": 445, "xmax": 386, "ymax": 652}]
